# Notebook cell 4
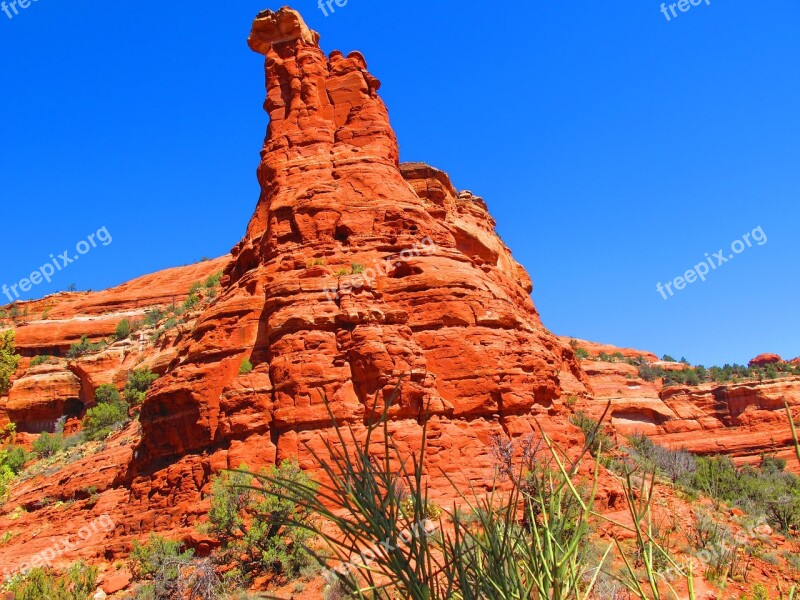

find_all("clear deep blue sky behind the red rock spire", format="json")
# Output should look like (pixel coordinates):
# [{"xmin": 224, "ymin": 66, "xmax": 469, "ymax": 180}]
[{"xmin": 0, "ymin": 0, "xmax": 800, "ymax": 365}]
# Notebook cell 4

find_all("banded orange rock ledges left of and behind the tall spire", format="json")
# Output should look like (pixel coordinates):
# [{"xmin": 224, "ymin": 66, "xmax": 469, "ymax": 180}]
[{"xmin": 0, "ymin": 258, "xmax": 229, "ymax": 433}]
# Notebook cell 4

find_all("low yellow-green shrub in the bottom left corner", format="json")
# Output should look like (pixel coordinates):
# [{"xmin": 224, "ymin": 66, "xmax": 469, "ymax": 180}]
[{"xmin": 6, "ymin": 562, "xmax": 98, "ymax": 600}]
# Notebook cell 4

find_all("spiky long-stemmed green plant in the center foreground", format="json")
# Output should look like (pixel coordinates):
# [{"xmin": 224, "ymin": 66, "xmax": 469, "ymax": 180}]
[{"xmin": 244, "ymin": 388, "xmax": 611, "ymax": 600}]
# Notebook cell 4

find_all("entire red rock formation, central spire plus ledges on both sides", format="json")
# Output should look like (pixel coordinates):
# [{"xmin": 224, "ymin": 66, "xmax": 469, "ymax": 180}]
[{"xmin": 0, "ymin": 9, "xmax": 800, "ymax": 588}]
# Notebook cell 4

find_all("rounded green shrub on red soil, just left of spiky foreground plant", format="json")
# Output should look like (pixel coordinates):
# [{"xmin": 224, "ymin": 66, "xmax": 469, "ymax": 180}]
[{"xmin": 208, "ymin": 461, "xmax": 316, "ymax": 578}]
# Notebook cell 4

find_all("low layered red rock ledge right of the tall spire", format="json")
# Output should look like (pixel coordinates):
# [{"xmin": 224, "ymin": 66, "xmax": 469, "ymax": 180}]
[{"xmin": 575, "ymin": 347, "xmax": 800, "ymax": 472}]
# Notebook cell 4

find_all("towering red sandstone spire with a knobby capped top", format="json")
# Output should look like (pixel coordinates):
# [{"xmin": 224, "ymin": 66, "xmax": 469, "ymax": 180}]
[{"xmin": 133, "ymin": 5, "xmax": 582, "ymax": 474}]
